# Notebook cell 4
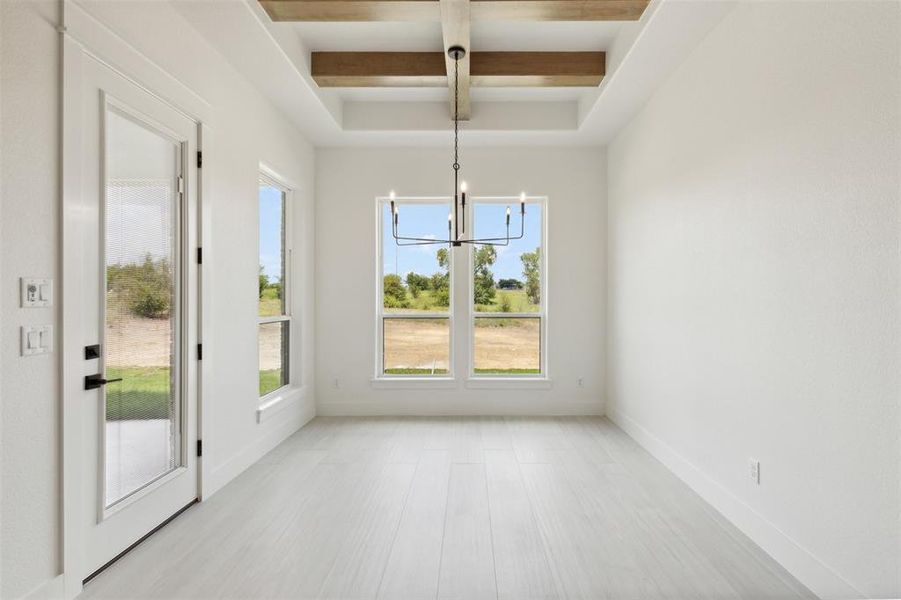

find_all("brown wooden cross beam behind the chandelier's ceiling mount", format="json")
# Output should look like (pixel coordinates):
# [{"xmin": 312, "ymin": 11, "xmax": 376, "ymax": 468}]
[{"xmin": 312, "ymin": 52, "xmax": 606, "ymax": 87}]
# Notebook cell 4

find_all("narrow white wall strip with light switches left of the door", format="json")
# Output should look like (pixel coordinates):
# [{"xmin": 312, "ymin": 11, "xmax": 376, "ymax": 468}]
[{"xmin": 0, "ymin": 0, "xmax": 60, "ymax": 598}]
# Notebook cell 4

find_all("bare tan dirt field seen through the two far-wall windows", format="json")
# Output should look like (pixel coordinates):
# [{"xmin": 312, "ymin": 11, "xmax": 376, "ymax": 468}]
[{"xmin": 385, "ymin": 319, "xmax": 540, "ymax": 370}]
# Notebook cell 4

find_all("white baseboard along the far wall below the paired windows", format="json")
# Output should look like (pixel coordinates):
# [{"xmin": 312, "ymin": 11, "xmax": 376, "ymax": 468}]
[{"xmin": 316, "ymin": 400, "xmax": 604, "ymax": 417}]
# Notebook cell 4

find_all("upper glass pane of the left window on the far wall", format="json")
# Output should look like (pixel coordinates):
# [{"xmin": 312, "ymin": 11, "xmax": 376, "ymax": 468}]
[{"xmin": 382, "ymin": 203, "xmax": 451, "ymax": 313}]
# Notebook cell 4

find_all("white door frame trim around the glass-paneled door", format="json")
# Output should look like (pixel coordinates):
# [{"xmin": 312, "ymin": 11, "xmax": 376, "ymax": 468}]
[{"xmin": 57, "ymin": 0, "xmax": 213, "ymax": 598}]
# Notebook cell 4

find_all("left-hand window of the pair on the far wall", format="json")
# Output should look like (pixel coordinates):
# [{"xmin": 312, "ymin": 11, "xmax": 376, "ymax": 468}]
[{"xmin": 377, "ymin": 199, "xmax": 453, "ymax": 377}]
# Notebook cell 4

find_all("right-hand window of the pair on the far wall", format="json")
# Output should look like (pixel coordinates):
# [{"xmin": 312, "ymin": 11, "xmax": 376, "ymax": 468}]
[{"xmin": 470, "ymin": 200, "xmax": 546, "ymax": 377}]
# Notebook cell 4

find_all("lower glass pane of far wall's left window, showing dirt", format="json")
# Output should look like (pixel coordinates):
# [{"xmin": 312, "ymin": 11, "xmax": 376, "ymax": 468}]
[{"xmin": 383, "ymin": 318, "xmax": 450, "ymax": 375}]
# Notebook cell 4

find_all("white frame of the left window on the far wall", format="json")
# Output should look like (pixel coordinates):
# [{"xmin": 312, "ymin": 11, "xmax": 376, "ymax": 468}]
[{"xmin": 374, "ymin": 196, "xmax": 457, "ymax": 383}]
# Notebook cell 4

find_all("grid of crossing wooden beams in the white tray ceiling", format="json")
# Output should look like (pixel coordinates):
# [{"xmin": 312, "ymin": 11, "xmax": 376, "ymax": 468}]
[{"xmin": 259, "ymin": 0, "xmax": 649, "ymax": 120}]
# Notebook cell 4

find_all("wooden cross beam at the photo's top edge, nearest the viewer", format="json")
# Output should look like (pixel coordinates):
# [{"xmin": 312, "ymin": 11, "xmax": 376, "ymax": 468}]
[{"xmin": 259, "ymin": 0, "xmax": 650, "ymax": 21}]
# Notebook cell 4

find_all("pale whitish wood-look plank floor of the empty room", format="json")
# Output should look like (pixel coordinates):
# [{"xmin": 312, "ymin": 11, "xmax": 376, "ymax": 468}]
[{"xmin": 81, "ymin": 417, "xmax": 813, "ymax": 600}]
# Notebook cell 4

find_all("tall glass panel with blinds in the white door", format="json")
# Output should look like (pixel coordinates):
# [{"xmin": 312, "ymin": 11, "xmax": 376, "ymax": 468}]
[{"xmin": 101, "ymin": 108, "xmax": 182, "ymax": 507}]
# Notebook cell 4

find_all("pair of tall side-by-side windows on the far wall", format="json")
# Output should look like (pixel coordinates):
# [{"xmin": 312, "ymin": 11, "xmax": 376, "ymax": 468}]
[{"xmin": 376, "ymin": 198, "xmax": 547, "ymax": 386}]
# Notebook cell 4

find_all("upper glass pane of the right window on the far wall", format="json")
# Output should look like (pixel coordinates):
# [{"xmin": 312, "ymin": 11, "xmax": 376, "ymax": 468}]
[{"xmin": 473, "ymin": 201, "xmax": 541, "ymax": 313}]
